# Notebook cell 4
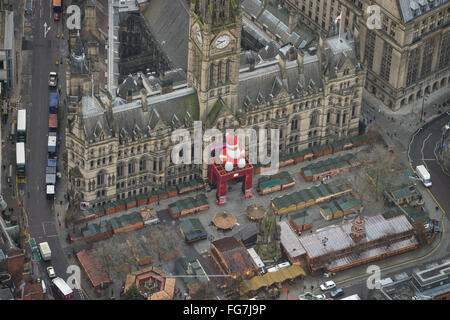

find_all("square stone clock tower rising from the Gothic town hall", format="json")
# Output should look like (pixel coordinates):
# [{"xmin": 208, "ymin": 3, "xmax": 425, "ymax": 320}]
[{"xmin": 187, "ymin": 0, "xmax": 242, "ymax": 121}]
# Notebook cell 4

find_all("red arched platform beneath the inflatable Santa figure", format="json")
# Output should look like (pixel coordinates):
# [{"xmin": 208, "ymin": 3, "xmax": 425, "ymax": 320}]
[{"xmin": 208, "ymin": 157, "xmax": 254, "ymax": 206}]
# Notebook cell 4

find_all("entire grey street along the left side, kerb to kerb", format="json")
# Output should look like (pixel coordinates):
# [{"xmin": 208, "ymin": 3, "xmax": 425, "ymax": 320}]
[{"xmin": 19, "ymin": 1, "xmax": 82, "ymax": 299}]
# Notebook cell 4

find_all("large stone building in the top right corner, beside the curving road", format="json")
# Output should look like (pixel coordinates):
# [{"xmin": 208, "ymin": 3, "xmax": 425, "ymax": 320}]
[{"xmin": 282, "ymin": 0, "xmax": 450, "ymax": 110}]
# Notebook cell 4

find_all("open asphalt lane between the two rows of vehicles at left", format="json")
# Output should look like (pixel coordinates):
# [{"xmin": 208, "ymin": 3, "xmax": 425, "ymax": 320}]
[{"xmin": 27, "ymin": 0, "xmax": 80, "ymax": 299}]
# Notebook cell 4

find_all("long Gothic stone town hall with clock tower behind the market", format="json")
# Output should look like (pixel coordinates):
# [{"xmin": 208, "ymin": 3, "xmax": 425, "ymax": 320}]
[{"xmin": 66, "ymin": 0, "xmax": 365, "ymax": 205}]
